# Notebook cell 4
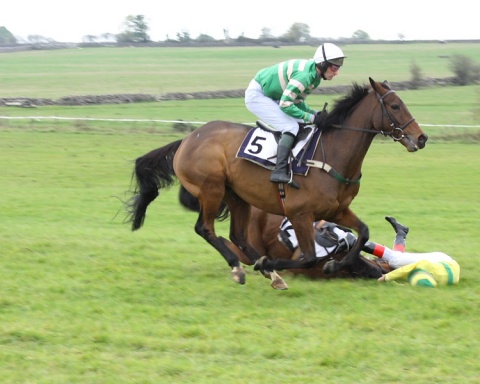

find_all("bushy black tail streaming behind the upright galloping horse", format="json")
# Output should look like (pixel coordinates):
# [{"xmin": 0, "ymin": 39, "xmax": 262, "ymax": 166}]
[{"xmin": 126, "ymin": 140, "xmax": 182, "ymax": 231}]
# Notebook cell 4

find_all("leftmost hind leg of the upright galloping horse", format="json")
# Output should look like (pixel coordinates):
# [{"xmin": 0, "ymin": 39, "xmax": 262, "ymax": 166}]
[{"xmin": 195, "ymin": 208, "xmax": 245, "ymax": 284}]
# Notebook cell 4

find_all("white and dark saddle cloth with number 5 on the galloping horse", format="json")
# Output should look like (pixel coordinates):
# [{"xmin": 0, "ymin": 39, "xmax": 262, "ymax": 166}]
[{"xmin": 236, "ymin": 126, "xmax": 321, "ymax": 176}]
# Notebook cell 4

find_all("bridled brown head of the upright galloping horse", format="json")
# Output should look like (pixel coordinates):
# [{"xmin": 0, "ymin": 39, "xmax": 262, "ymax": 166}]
[{"xmin": 369, "ymin": 77, "xmax": 428, "ymax": 152}]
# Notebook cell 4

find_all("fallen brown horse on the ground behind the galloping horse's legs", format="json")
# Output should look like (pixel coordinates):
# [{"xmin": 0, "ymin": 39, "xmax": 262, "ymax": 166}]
[{"xmin": 244, "ymin": 207, "xmax": 392, "ymax": 279}]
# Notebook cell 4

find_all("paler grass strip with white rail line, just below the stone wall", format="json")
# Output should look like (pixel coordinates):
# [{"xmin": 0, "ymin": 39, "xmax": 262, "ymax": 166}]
[{"xmin": 0, "ymin": 85, "xmax": 480, "ymax": 141}]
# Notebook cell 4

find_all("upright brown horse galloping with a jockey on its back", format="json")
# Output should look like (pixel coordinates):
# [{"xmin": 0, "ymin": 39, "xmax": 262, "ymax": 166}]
[{"xmin": 128, "ymin": 78, "xmax": 427, "ymax": 284}]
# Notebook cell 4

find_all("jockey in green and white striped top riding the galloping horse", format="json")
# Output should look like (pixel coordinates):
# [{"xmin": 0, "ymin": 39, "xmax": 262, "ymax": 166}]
[{"xmin": 245, "ymin": 43, "xmax": 345, "ymax": 188}]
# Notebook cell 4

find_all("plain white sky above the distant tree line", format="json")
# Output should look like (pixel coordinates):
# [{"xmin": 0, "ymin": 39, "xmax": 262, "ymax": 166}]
[{"xmin": 0, "ymin": 0, "xmax": 480, "ymax": 42}]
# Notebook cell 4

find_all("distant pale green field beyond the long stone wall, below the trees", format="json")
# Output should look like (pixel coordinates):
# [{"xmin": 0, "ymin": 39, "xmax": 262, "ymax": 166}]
[{"xmin": 0, "ymin": 43, "xmax": 480, "ymax": 99}]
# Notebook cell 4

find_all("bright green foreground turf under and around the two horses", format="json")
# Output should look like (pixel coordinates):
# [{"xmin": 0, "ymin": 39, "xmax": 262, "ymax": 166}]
[{"xmin": 0, "ymin": 129, "xmax": 480, "ymax": 384}]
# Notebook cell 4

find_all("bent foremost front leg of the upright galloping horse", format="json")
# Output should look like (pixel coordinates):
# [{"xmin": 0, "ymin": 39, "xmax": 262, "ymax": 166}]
[{"xmin": 323, "ymin": 209, "xmax": 370, "ymax": 274}]
